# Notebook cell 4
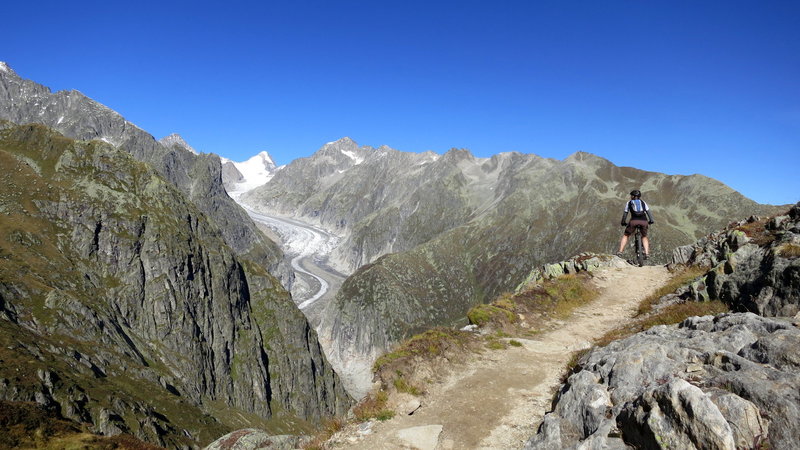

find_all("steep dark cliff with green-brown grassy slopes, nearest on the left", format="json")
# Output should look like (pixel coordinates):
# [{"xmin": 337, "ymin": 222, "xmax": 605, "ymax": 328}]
[{"xmin": 0, "ymin": 125, "xmax": 349, "ymax": 447}]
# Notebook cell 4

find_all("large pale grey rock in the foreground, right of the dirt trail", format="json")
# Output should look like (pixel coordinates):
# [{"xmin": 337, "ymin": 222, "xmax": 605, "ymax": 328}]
[{"xmin": 525, "ymin": 313, "xmax": 800, "ymax": 449}]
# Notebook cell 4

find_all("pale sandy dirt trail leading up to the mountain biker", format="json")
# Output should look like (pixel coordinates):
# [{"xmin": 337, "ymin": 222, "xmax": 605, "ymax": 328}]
[{"xmin": 331, "ymin": 266, "xmax": 669, "ymax": 450}]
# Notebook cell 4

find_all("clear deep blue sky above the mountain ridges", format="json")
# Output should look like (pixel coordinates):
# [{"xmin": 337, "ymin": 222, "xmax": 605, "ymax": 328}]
[{"xmin": 0, "ymin": 0, "xmax": 800, "ymax": 204}]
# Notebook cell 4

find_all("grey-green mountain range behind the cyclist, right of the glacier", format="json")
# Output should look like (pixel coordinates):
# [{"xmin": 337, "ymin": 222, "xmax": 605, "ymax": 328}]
[{"xmin": 240, "ymin": 138, "xmax": 781, "ymax": 394}]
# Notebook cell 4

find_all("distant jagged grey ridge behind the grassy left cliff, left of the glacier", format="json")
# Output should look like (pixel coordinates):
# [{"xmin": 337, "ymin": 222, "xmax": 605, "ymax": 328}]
[{"xmin": 0, "ymin": 66, "xmax": 291, "ymax": 286}]
